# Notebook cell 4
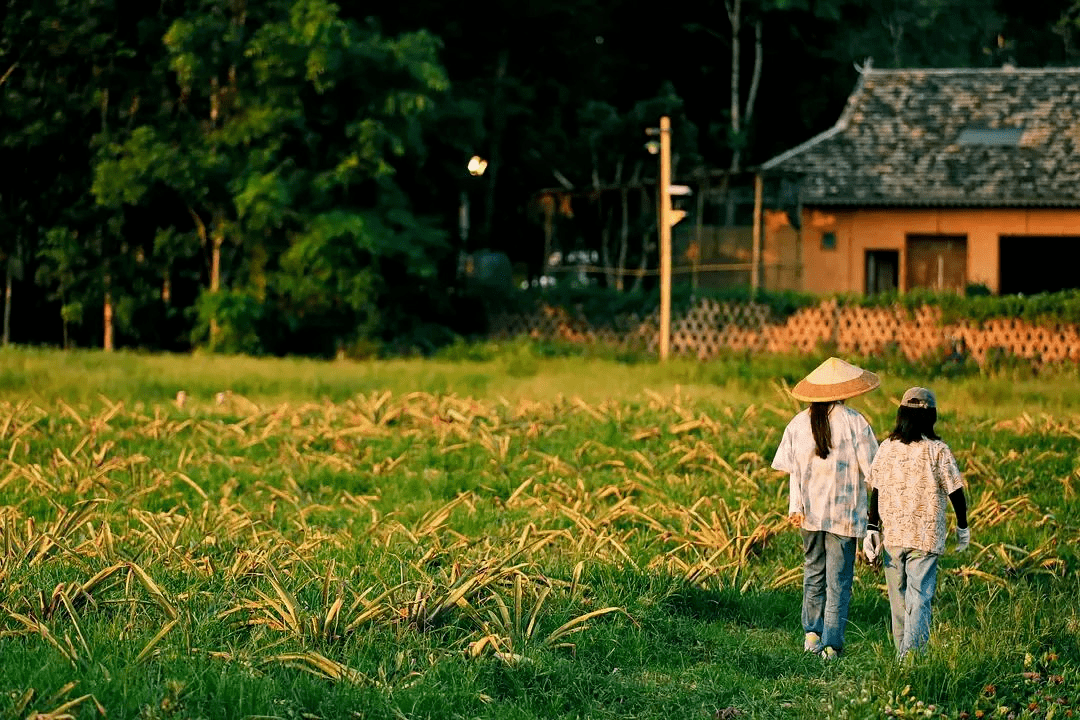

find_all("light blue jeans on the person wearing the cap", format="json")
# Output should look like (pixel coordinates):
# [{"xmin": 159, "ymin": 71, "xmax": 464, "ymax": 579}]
[{"xmin": 881, "ymin": 547, "xmax": 940, "ymax": 657}]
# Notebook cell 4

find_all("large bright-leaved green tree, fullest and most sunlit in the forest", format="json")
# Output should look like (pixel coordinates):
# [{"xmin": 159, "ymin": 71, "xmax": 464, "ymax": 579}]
[{"xmin": 94, "ymin": 0, "xmax": 447, "ymax": 351}]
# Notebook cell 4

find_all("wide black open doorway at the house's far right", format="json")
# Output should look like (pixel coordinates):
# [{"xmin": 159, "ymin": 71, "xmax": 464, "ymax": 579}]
[{"xmin": 998, "ymin": 235, "xmax": 1080, "ymax": 295}]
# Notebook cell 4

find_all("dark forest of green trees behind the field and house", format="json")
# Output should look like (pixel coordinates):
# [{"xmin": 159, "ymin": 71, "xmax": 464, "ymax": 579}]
[{"xmin": 0, "ymin": 0, "xmax": 1080, "ymax": 356}]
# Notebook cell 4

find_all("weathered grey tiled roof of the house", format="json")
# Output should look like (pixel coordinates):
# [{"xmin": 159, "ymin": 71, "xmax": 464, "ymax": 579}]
[{"xmin": 760, "ymin": 67, "xmax": 1080, "ymax": 207}]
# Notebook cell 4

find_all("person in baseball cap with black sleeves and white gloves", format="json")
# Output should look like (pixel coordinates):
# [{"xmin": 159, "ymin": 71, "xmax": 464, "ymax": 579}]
[{"xmin": 863, "ymin": 388, "xmax": 971, "ymax": 657}]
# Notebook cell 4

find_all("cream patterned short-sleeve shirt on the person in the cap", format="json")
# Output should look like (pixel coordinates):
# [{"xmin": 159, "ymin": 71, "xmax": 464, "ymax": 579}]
[{"xmin": 870, "ymin": 438, "xmax": 963, "ymax": 555}]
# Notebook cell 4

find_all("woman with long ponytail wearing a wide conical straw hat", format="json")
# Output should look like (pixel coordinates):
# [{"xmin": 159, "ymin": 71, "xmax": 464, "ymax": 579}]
[{"xmin": 772, "ymin": 357, "xmax": 880, "ymax": 660}]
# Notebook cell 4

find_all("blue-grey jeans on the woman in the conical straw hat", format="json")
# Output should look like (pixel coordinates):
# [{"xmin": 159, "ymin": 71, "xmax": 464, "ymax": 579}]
[{"xmin": 802, "ymin": 530, "xmax": 858, "ymax": 652}]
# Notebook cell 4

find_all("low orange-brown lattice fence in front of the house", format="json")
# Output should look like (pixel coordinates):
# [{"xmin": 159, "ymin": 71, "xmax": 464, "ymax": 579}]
[{"xmin": 492, "ymin": 299, "xmax": 1080, "ymax": 365}]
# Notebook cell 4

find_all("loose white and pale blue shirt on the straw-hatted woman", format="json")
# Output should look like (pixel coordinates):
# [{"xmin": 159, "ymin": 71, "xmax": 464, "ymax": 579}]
[{"xmin": 772, "ymin": 404, "xmax": 878, "ymax": 538}]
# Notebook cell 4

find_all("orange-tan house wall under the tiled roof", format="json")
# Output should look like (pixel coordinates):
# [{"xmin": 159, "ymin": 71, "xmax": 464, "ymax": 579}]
[{"xmin": 786, "ymin": 208, "xmax": 1080, "ymax": 294}]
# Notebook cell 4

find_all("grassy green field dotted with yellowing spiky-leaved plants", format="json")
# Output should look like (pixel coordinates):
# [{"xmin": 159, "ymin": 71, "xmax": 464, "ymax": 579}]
[{"xmin": 0, "ymin": 345, "xmax": 1080, "ymax": 720}]
